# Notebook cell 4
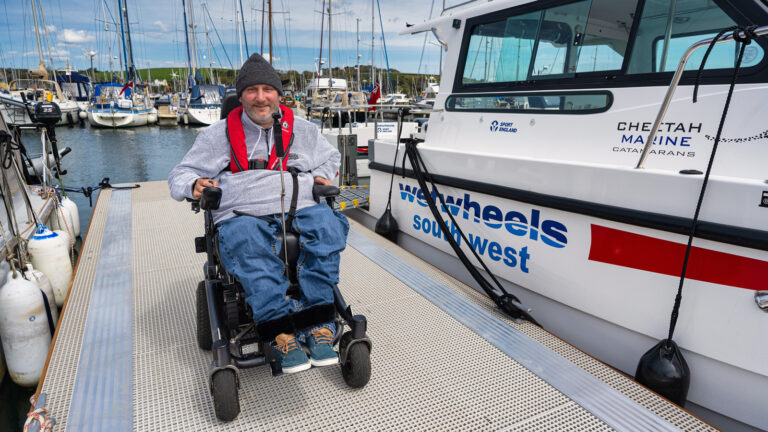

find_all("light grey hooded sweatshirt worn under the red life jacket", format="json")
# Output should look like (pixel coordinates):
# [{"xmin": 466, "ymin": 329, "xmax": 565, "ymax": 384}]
[{"xmin": 168, "ymin": 111, "xmax": 341, "ymax": 223}]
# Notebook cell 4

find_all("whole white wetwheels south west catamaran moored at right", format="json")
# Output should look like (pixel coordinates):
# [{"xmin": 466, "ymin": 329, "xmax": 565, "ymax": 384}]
[{"xmin": 361, "ymin": 0, "xmax": 768, "ymax": 430}]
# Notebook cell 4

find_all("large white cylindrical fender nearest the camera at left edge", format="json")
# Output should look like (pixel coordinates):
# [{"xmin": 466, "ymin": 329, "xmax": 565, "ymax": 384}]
[{"xmin": 0, "ymin": 272, "xmax": 51, "ymax": 387}]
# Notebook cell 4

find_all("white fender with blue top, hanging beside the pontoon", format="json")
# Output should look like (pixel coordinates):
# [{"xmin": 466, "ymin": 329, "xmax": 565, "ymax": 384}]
[{"xmin": 27, "ymin": 224, "xmax": 72, "ymax": 307}]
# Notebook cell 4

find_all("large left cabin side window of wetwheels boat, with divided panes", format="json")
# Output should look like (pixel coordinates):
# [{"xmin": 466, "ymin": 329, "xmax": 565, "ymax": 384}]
[{"xmin": 462, "ymin": 0, "xmax": 637, "ymax": 84}]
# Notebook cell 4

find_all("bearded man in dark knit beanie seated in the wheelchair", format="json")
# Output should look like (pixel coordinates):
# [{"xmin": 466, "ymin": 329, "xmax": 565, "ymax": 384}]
[{"xmin": 168, "ymin": 54, "xmax": 349, "ymax": 373}]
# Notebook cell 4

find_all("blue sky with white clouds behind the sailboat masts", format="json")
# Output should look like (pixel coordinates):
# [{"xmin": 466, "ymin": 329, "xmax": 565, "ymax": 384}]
[{"xmin": 0, "ymin": 0, "xmax": 452, "ymax": 74}]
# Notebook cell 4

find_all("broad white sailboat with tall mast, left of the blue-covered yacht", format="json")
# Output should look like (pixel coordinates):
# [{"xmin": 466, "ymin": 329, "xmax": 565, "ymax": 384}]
[{"xmin": 88, "ymin": 0, "xmax": 157, "ymax": 128}]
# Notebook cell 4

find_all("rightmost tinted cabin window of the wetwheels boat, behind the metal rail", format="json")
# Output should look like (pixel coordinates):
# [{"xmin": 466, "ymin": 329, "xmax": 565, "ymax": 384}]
[{"xmin": 627, "ymin": 0, "xmax": 763, "ymax": 74}]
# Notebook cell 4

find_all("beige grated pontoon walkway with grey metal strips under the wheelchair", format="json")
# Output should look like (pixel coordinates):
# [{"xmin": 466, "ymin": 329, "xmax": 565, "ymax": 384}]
[{"xmin": 33, "ymin": 182, "xmax": 713, "ymax": 431}]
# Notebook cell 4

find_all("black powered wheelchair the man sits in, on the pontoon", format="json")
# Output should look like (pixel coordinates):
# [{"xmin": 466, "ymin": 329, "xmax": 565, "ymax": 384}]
[{"xmin": 188, "ymin": 98, "xmax": 371, "ymax": 421}]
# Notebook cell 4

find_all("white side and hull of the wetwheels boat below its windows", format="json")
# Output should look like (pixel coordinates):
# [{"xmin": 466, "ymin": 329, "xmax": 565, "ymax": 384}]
[{"xmin": 370, "ymin": 82, "xmax": 768, "ymax": 429}]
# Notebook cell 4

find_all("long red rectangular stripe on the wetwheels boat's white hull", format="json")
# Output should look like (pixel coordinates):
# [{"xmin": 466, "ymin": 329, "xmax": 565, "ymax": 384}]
[{"xmin": 589, "ymin": 225, "xmax": 768, "ymax": 290}]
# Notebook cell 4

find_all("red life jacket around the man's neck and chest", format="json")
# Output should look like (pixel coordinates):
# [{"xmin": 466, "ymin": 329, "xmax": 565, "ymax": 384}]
[{"xmin": 227, "ymin": 104, "xmax": 293, "ymax": 173}]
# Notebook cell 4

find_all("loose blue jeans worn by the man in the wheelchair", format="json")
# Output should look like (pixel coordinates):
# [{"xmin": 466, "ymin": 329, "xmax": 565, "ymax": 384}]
[{"xmin": 217, "ymin": 204, "xmax": 349, "ymax": 330}]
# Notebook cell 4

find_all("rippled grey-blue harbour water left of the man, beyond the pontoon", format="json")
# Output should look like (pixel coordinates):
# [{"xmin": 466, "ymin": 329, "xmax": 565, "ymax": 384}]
[{"xmin": 0, "ymin": 122, "xmax": 203, "ymax": 432}]
